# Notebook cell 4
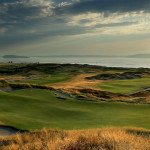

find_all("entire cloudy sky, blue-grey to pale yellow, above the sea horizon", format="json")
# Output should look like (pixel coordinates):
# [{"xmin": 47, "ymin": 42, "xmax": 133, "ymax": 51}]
[{"xmin": 0, "ymin": 0, "xmax": 150, "ymax": 56}]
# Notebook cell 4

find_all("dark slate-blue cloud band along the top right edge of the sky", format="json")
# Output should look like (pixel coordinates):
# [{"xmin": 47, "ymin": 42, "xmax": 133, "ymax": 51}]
[{"xmin": 60, "ymin": 0, "xmax": 150, "ymax": 13}]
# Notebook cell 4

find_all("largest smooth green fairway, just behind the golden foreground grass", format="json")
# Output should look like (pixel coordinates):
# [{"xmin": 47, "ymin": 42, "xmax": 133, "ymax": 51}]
[{"xmin": 0, "ymin": 89, "xmax": 150, "ymax": 129}]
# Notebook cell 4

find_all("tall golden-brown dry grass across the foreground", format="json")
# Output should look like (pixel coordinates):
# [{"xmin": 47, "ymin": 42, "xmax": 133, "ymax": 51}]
[{"xmin": 0, "ymin": 128, "xmax": 150, "ymax": 150}]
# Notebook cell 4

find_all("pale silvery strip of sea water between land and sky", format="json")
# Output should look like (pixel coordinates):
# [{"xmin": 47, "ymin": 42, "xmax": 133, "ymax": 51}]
[{"xmin": 0, "ymin": 56, "xmax": 150, "ymax": 68}]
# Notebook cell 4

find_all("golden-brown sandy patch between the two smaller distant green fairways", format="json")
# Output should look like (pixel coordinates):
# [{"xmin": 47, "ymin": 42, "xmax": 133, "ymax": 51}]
[{"xmin": 52, "ymin": 74, "xmax": 101, "ymax": 89}]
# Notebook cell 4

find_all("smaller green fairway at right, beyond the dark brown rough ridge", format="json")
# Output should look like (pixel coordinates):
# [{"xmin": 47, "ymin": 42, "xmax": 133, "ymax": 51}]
[{"xmin": 97, "ymin": 77, "xmax": 150, "ymax": 94}]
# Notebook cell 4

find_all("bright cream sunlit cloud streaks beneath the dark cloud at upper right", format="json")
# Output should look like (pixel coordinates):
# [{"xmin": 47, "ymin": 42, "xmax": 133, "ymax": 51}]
[{"xmin": 68, "ymin": 11, "xmax": 150, "ymax": 34}]
